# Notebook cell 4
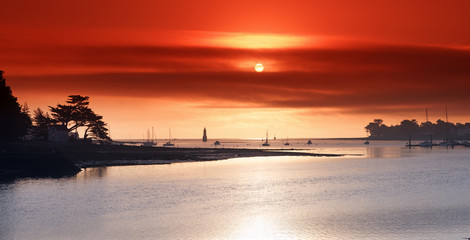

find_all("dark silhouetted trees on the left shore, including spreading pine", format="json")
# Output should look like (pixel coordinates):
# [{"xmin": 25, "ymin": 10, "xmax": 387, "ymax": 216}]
[{"xmin": 0, "ymin": 71, "xmax": 111, "ymax": 142}]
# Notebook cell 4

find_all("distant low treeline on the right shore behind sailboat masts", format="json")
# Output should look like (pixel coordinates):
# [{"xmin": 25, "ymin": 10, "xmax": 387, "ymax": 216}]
[{"xmin": 365, "ymin": 119, "xmax": 470, "ymax": 140}]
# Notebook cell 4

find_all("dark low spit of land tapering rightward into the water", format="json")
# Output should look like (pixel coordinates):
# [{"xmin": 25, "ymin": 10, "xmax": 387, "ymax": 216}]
[{"xmin": 0, "ymin": 141, "xmax": 342, "ymax": 179}]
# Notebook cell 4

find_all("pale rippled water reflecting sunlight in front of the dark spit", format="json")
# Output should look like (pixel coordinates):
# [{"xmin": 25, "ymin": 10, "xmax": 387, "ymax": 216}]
[{"xmin": 0, "ymin": 142, "xmax": 470, "ymax": 240}]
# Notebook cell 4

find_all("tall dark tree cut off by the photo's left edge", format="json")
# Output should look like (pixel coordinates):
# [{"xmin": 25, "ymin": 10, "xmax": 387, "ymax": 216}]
[{"xmin": 0, "ymin": 71, "xmax": 31, "ymax": 141}]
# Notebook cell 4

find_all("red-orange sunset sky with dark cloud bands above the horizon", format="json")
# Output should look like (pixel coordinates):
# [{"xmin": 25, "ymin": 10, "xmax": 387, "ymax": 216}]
[{"xmin": 0, "ymin": 0, "xmax": 470, "ymax": 139}]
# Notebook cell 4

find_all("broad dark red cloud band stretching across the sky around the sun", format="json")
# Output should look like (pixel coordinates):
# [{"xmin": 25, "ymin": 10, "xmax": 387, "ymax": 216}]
[{"xmin": 1, "ymin": 45, "xmax": 470, "ymax": 118}]
